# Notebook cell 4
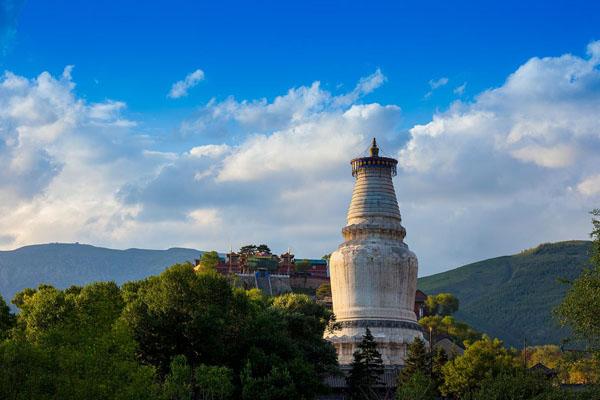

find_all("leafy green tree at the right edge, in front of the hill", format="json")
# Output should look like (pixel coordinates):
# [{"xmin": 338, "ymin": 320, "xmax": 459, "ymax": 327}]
[{"xmin": 555, "ymin": 209, "xmax": 600, "ymax": 351}]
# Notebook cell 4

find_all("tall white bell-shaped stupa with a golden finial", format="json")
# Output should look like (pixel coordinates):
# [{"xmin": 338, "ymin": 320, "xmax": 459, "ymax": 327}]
[{"xmin": 326, "ymin": 139, "xmax": 423, "ymax": 366}]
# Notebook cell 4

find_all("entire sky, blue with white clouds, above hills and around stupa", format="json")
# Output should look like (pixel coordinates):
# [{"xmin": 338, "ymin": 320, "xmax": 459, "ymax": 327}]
[{"xmin": 0, "ymin": 0, "xmax": 600, "ymax": 275}]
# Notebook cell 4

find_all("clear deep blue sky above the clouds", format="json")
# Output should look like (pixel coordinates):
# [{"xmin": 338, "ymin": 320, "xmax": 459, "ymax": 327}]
[{"xmin": 5, "ymin": 0, "xmax": 600, "ymax": 134}]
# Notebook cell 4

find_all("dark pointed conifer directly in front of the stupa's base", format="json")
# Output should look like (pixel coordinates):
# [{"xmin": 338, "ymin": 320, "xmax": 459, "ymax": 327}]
[{"xmin": 346, "ymin": 328, "xmax": 383, "ymax": 400}]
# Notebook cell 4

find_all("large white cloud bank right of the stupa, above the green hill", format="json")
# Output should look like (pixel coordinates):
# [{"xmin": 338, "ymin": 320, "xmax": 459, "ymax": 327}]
[{"xmin": 398, "ymin": 42, "xmax": 600, "ymax": 264}]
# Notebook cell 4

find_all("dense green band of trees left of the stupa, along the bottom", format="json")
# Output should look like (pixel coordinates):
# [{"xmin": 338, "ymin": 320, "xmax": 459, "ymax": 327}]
[{"xmin": 0, "ymin": 264, "xmax": 337, "ymax": 400}]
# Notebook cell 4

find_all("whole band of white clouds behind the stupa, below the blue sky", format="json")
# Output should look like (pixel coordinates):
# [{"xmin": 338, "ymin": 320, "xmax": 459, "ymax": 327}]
[{"xmin": 0, "ymin": 42, "xmax": 600, "ymax": 274}]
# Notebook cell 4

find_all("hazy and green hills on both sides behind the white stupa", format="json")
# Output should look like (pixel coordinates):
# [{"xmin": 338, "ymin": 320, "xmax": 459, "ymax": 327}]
[{"xmin": 0, "ymin": 241, "xmax": 591, "ymax": 347}]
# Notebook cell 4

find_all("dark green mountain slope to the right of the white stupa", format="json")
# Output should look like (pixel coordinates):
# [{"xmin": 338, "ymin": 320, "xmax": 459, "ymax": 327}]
[{"xmin": 418, "ymin": 241, "xmax": 591, "ymax": 348}]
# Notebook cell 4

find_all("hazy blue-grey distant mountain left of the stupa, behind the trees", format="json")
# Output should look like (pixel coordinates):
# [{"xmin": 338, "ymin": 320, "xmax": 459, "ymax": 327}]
[{"xmin": 0, "ymin": 243, "xmax": 202, "ymax": 302}]
